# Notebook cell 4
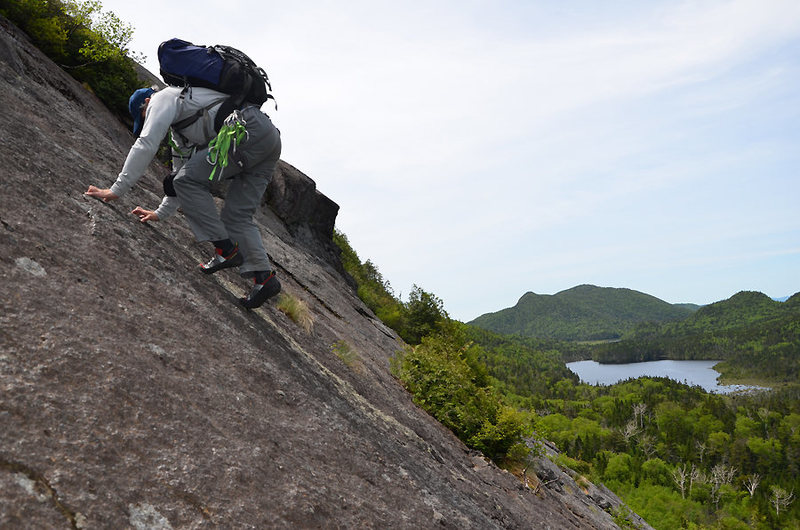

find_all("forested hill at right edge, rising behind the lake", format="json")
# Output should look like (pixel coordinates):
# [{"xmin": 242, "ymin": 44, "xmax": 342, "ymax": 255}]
[{"xmin": 592, "ymin": 291, "xmax": 800, "ymax": 382}]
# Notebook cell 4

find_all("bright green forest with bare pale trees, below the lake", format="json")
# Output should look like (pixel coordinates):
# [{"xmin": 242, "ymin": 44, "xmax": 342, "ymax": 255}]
[{"xmin": 517, "ymin": 378, "xmax": 800, "ymax": 530}]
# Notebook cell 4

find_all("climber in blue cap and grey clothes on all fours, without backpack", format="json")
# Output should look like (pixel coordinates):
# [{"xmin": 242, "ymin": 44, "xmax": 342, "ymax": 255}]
[{"xmin": 86, "ymin": 86, "xmax": 281, "ymax": 308}]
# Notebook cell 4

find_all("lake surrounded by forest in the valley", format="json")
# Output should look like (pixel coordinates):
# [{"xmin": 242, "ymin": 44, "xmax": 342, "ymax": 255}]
[{"xmin": 567, "ymin": 361, "xmax": 763, "ymax": 394}]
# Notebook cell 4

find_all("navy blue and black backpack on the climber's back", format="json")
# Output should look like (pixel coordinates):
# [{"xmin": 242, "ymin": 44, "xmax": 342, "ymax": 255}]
[{"xmin": 158, "ymin": 39, "xmax": 277, "ymax": 108}]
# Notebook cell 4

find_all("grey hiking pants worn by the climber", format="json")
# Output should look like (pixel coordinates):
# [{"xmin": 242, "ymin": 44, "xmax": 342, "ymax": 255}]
[{"xmin": 173, "ymin": 107, "xmax": 281, "ymax": 278}]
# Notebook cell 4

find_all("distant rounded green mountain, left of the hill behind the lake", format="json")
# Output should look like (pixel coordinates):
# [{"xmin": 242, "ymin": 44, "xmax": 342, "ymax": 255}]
[{"xmin": 469, "ymin": 285, "xmax": 699, "ymax": 341}]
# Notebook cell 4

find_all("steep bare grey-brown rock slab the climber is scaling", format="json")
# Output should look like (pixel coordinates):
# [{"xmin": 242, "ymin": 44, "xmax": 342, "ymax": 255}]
[{"xmin": 0, "ymin": 16, "xmax": 632, "ymax": 529}]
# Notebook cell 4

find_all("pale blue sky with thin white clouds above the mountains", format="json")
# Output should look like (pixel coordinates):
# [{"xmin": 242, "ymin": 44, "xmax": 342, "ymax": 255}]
[{"xmin": 97, "ymin": 0, "xmax": 800, "ymax": 321}]
